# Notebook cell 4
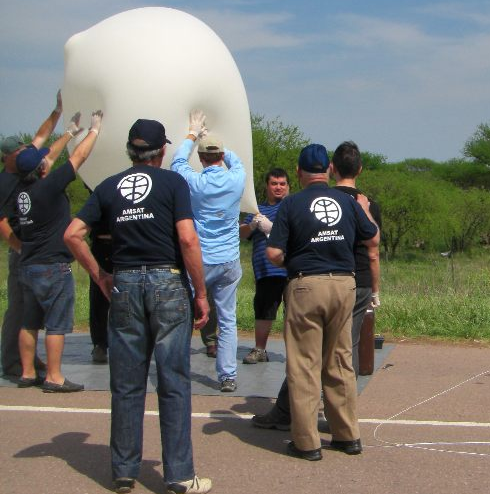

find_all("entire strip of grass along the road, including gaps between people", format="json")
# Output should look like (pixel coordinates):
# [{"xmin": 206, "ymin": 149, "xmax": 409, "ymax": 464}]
[{"xmin": 0, "ymin": 241, "xmax": 490, "ymax": 343}]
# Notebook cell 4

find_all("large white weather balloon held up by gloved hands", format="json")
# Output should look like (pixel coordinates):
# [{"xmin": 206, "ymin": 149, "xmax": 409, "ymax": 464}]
[{"xmin": 62, "ymin": 7, "xmax": 257, "ymax": 212}]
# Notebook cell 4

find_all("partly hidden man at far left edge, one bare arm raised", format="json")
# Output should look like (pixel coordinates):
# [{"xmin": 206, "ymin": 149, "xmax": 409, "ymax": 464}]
[{"xmin": 0, "ymin": 91, "xmax": 63, "ymax": 377}]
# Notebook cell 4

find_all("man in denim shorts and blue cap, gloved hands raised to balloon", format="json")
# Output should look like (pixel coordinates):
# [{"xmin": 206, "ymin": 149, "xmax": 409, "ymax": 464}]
[{"xmin": 15, "ymin": 111, "xmax": 102, "ymax": 393}]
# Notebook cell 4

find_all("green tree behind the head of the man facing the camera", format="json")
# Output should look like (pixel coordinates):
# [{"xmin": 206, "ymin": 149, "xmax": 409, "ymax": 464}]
[{"xmin": 251, "ymin": 114, "xmax": 310, "ymax": 202}]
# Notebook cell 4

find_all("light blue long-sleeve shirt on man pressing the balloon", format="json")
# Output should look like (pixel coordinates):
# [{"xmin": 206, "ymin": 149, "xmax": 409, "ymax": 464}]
[{"xmin": 170, "ymin": 139, "xmax": 245, "ymax": 264}]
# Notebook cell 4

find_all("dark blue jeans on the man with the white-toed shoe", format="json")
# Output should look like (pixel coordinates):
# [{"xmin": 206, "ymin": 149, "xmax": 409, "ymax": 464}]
[{"xmin": 109, "ymin": 266, "xmax": 194, "ymax": 482}]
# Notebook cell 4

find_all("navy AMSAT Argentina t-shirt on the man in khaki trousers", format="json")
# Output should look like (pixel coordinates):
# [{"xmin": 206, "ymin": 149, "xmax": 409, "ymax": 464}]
[{"xmin": 267, "ymin": 183, "xmax": 377, "ymax": 276}]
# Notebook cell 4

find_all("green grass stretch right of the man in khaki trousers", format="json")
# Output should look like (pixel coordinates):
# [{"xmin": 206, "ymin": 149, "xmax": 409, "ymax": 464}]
[{"xmin": 376, "ymin": 252, "xmax": 490, "ymax": 342}]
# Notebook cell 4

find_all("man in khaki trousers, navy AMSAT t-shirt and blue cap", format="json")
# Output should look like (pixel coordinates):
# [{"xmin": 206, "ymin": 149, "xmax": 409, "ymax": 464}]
[{"xmin": 266, "ymin": 144, "xmax": 379, "ymax": 461}]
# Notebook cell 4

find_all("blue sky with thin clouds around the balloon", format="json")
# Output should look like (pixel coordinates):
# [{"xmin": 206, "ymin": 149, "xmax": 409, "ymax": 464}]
[{"xmin": 0, "ymin": 0, "xmax": 490, "ymax": 161}]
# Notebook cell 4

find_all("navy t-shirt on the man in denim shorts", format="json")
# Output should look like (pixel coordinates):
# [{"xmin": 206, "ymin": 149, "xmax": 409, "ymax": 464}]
[{"xmin": 15, "ymin": 161, "xmax": 75, "ymax": 264}]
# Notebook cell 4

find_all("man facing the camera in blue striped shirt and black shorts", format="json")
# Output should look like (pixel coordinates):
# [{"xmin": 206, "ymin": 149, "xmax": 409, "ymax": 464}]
[{"xmin": 240, "ymin": 168, "xmax": 289, "ymax": 364}]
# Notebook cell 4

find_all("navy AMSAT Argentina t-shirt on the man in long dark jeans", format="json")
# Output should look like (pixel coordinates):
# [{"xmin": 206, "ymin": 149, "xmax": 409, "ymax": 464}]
[{"xmin": 77, "ymin": 165, "xmax": 193, "ymax": 267}]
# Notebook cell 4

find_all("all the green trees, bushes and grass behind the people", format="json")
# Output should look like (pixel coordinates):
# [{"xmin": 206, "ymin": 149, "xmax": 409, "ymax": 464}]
[{"xmin": 0, "ymin": 115, "xmax": 490, "ymax": 344}]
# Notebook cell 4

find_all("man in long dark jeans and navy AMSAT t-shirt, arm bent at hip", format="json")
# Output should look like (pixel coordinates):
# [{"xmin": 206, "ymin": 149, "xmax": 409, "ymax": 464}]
[{"xmin": 65, "ymin": 119, "xmax": 211, "ymax": 494}]
